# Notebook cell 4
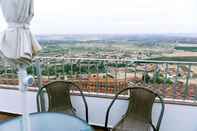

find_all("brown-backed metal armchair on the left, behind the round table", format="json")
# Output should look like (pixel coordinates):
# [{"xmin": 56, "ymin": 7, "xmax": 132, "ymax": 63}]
[{"xmin": 37, "ymin": 81, "xmax": 88, "ymax": 122}]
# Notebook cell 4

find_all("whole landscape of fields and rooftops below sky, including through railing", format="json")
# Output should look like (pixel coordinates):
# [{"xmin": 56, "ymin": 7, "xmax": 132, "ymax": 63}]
[{"xmin": 1, "ymin": 34, "xmax": 197, "ymax": 99}]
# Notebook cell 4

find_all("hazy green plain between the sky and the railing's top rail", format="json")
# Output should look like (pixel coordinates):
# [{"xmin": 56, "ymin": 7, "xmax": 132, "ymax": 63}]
[{"xmin": 37, "ymin": 34, "xmax": 197, "ymax": 62}]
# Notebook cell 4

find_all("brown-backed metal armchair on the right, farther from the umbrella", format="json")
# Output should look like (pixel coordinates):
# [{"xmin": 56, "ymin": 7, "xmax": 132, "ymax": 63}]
[{"xmin": 105, "ymin": 87, "xmax": 165, "ymax": 131}]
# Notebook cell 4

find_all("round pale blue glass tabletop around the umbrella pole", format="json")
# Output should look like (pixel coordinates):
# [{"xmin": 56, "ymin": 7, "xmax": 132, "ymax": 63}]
[{"xmin": 0, "ymin": 112, "xmax": 94, "ymax": 131}]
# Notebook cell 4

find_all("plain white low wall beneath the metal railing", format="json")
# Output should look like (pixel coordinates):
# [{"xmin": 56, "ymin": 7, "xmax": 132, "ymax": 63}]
[{"xmin": 0, "ymin": 89, "xmax": 197, "ymax": 131}]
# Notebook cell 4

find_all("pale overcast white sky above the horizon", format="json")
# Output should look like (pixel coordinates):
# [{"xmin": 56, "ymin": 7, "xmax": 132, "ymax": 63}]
[{"xmin": 0, "ymin": 0, "xmax": 197, "ymax": 34}]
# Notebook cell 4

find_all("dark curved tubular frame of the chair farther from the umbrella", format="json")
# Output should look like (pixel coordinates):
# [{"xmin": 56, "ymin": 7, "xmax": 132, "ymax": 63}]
[{"xmin": 105, "ymin": 86, "xmax": 165, "ymax": 131}]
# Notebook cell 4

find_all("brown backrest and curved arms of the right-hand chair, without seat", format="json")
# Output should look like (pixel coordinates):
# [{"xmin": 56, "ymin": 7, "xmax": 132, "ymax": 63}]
[{"xmin": 105, "ymin": 87, "xmax": 164, "ymax": 131}]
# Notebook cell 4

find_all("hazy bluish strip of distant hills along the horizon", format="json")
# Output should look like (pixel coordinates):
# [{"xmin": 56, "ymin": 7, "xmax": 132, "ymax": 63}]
[{"xmin": 36, "ymin": 34, "xmax": 197, "ymax": 44}]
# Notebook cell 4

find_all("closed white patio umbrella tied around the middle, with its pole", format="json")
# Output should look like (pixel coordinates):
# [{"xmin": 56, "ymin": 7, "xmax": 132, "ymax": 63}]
[{"xmin": 0, "ymin": 0, "xmax": 41, "ymax": 131}]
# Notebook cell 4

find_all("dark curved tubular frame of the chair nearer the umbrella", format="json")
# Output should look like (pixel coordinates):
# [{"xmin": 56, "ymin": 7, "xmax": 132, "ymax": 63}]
[{"xmin": 36, "ymin": 81, "xmax": 89, "ymax": 123}]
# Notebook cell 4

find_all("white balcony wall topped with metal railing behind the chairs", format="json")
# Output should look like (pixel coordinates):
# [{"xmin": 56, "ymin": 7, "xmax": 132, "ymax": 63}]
[{"xmin": 0, "ymin": 57, "xmax": 197, "ymax": 131}]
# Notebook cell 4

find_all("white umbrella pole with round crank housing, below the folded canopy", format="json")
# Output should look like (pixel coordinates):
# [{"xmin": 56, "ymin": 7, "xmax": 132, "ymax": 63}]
[{"xmin": 18, "ymin": 65, "xmax": 33, "ymax": 131}]
